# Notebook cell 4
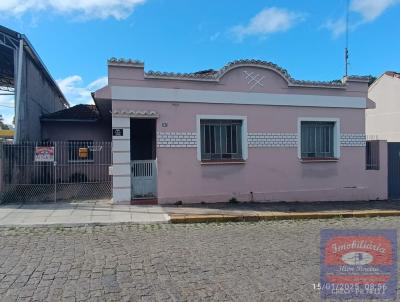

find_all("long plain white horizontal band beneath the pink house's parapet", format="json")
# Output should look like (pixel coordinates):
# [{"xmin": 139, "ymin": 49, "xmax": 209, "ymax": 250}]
[{"xmin": 111, "ymin": 86, "xmax": 367, "ymax": 109}]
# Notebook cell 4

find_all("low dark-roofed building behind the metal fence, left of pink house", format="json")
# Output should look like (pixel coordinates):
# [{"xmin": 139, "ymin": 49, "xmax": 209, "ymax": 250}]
[{"xmin": 40, "ymin": 105, "xmax": 111, "ymax": 188}]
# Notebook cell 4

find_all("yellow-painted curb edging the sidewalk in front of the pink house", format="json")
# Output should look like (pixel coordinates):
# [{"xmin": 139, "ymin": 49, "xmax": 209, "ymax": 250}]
[{"xmin": 169, "ymin": 210, "xmax": 400, "ymax": 223}]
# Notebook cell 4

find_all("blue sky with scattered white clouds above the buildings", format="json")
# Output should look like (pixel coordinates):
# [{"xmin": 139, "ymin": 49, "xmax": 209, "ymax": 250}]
[{"xmin": 0, "ymin": 0, "xmax": 400, "ymax": 122}]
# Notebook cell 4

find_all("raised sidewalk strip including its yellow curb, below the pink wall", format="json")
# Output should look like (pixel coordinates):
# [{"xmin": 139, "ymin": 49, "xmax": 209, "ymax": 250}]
[{"xmin": 163, "ymin": 201, "xmax": 400, "ymax": 223}]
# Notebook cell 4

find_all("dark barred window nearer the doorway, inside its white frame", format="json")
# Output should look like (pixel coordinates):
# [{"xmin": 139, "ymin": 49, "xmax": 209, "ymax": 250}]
[{"xmin": 200, "ymin": 120, "xmax": 243, "ymax": 160}]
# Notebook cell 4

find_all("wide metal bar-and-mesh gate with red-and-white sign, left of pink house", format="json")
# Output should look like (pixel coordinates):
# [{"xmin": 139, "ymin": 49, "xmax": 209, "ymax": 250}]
[{"xmin": 0, "ymin": 141, "xmax": 112, "ymax": 202}]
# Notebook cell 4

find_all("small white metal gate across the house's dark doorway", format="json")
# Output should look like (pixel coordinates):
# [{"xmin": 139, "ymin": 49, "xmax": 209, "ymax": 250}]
[{"xmin": 131, "ymin": 160, "xmax": 157, "ymax": 199}]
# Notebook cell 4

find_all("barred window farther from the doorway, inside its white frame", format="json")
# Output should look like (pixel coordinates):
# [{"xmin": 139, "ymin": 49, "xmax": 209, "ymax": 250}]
[{"xmin": 301, "ymin": 121, "xmax": 335, "ymax": 159}]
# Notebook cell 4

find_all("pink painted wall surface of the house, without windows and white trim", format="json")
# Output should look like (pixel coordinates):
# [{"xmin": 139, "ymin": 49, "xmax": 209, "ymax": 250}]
[{"xmin": 109, "ymin": 61, "xmax": 387, "ymax": 203}]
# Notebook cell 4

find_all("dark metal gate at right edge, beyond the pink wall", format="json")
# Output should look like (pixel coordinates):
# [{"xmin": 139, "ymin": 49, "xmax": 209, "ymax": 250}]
[{"xmin": 388, "ymin": 143, "xmax": 400, "ymax": 199}]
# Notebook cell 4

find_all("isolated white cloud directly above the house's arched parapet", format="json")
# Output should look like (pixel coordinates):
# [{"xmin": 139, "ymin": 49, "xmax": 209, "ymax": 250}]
[{"xmin": 232, "ymin": 7, "xmax": 304, "ymax": 41}]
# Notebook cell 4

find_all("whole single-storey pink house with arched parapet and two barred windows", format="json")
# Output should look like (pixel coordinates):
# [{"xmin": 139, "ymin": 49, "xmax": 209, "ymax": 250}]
[{"xmin": 94, "ymin": 59, "xmax": 387, "ymax": 204}]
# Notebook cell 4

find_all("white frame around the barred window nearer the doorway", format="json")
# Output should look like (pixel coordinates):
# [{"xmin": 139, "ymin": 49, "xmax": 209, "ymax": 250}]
[{"xmin": 196, "ymin": 114, "xmax": 248, "ymax": 161}]
